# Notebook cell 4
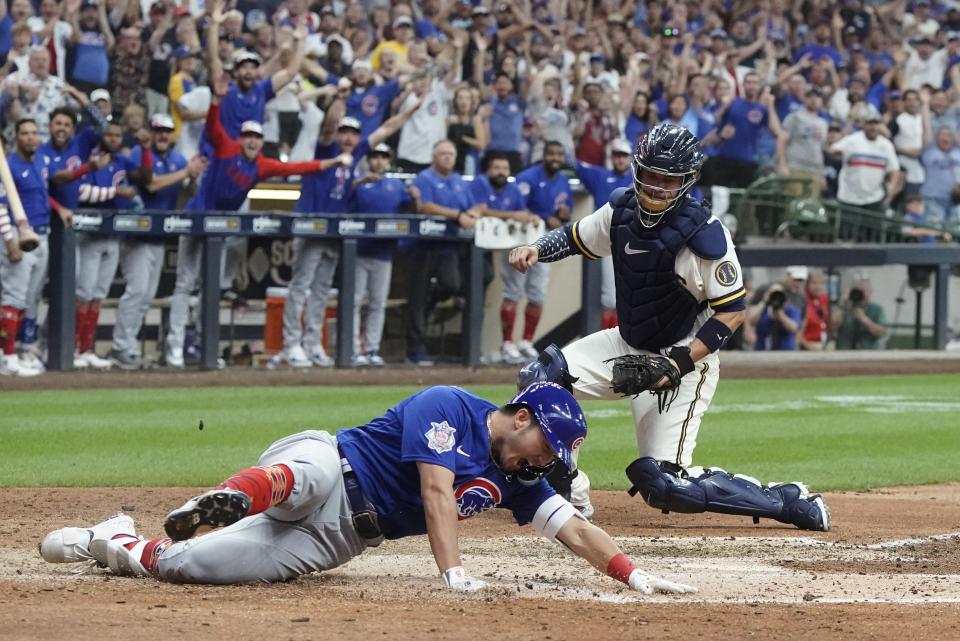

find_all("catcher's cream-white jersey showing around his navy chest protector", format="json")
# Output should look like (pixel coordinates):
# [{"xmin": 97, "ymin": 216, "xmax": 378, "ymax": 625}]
[{"xmin": 573, "ymin": 203, "xmax": 746, "ymax": 345}]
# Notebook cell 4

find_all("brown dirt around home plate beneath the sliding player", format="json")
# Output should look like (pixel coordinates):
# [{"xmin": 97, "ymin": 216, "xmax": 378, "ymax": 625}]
[{"xmin": 0, "ymin": 484, "xmax": 960, "ymax": 641}]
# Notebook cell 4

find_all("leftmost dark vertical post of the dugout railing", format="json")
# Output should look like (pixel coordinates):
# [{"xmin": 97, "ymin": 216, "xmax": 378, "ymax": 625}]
[{"xmin": 47, "ymin": 216, "xmax": 77, "ymax": 371}]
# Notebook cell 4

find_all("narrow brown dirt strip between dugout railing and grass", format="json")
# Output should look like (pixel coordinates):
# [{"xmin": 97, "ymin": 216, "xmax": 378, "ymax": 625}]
[{"xmin": 0, "ymin": 351, "xmax": 960, "ymax": 390}]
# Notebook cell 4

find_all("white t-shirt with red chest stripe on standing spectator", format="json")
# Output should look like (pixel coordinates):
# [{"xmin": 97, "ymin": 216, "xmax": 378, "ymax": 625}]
[{"xmin": 830, "ymin": 131, "xmax": 900, "ymax": 205}]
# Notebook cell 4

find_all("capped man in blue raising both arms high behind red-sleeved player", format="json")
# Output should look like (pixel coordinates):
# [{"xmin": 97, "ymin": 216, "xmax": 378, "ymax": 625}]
[{"xmin": 201, "ymin": 0, "xmax": 307, "ymax": 141}]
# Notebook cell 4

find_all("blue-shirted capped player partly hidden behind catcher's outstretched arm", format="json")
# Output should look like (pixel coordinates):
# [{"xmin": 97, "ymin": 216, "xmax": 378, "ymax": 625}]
[{"xmin": 572, "ymin": 138, "xmax": 634, "ymax": 329}]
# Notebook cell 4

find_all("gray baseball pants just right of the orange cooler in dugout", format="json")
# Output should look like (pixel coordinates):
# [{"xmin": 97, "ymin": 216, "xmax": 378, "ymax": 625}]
[{"xmin": 283, "ymin": 238, "xmax": 340, "ymax": 352}]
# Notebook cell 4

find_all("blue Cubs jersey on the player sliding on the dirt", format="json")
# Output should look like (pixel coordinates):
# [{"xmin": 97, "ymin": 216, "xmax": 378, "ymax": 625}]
[{"xmin": 337, "ymin": 386, "xmax": 555, "ymax": 539}]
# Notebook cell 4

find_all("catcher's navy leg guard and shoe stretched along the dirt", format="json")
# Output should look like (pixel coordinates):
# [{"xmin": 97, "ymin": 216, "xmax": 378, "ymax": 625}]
[{"xmin": 627, "ymin": 457, "xmax": 830, "ymax": 531}]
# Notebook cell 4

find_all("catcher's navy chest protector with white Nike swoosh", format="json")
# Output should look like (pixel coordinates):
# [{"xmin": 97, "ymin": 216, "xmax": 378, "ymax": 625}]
[{"xmin": 610, "ymin": 189, "xmax": 710, "ymax": 351}]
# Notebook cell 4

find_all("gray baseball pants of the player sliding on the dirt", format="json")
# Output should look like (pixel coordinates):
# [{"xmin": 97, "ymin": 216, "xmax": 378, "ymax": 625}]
[{"xmin": 158, "ymin": 430, "xmax": 367, "ymax": 585}]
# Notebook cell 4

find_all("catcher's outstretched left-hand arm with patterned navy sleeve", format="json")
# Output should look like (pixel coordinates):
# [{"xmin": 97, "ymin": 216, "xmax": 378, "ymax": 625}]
[{"xmin": 510, "ymin": 203, "xmax": 613, "ymax": 272}]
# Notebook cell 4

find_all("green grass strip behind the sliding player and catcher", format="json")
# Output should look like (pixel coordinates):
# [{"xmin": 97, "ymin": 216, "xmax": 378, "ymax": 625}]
[{"xmin": 0, "ymin": 375, "xmax": 960, "ymax": 490}]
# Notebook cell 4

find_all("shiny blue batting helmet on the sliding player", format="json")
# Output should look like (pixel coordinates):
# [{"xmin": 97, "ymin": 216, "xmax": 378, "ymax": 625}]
[{"xmin": 509, "ymin": 382, "xmax": 587, "ymax": 476}]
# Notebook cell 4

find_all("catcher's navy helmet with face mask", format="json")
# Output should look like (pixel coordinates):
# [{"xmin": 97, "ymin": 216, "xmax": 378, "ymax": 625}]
[{"xmin": 633, "ymin": 122, "xmax": 704, "ymax": 227}]
